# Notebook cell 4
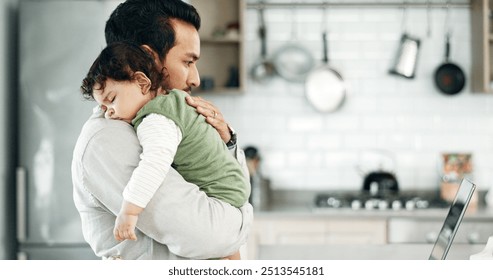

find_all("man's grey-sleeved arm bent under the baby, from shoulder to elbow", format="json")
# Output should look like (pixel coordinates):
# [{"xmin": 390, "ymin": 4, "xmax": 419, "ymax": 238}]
[{"xmin": 76, "ymin": 119, "xmax": 253, "ymax": 259}]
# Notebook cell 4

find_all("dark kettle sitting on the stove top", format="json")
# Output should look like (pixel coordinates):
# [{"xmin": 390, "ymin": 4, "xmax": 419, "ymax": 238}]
[{"xmin": 363, "ymin": 171, "xmax": 399, "ymax": 196}]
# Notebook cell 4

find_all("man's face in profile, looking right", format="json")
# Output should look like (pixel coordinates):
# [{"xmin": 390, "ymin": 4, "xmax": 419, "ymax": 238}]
[{"xmin": 158, "ymin": 20, "xmax": 200, "ymax": 94}]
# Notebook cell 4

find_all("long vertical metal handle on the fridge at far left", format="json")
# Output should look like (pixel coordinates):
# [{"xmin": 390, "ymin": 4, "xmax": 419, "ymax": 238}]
[{"xmin": 16, "ymin": 167, "xmax": 27, "ymax": 242}]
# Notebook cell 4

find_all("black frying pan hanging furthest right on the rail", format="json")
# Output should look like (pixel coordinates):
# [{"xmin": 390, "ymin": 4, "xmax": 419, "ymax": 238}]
[{"xmin": 435, "ymin": 1, "xmax": 466, "ymax": 95}]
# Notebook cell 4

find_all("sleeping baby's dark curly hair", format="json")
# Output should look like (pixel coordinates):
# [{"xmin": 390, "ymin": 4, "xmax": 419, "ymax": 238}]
[{"xmin": 80, "ymin": 42, "xmax": 164, "ymax": 100}]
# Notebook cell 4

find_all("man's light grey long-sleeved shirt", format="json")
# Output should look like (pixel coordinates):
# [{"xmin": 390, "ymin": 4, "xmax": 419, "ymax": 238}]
[{"xmin": 72, "ymin": 107, "xmax": 253, "ymax": 259}]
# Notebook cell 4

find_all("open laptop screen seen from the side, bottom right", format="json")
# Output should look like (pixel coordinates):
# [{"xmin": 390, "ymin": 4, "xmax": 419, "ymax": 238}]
[{"xmin": 429, "ymin": 178, "xmax": 476, "ymax": 260}]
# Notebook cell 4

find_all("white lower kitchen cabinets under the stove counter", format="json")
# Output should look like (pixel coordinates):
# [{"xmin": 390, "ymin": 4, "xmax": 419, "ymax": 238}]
[{"xmin": 242, "ymin": 213, "xmax": 493, "ymax": 260}]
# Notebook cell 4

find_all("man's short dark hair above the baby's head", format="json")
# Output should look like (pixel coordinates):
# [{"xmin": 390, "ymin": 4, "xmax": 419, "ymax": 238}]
[{"xmin": 105, "ymin": 0, "xmax": 200, "ymax": 59}]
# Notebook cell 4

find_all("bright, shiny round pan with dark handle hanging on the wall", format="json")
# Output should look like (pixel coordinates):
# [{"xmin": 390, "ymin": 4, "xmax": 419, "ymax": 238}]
[{"xmin": 305, "ymin": 10, "xmax": 346, "ymax": 113}]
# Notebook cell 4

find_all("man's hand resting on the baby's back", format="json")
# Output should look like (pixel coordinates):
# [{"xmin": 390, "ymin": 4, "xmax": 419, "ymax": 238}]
[{"xmin": 186, "ymin": 96, "xmax": 231, "ymax": 143}]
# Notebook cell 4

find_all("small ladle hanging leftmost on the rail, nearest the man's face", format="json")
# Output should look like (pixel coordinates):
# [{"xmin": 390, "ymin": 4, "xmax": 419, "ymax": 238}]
[{"xmin": 251, "ymin": 8, "xmax": 276, "ymax": 83}]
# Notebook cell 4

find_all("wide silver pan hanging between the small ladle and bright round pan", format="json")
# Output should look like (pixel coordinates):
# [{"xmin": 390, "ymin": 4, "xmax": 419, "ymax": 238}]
[{"xmin": 273, "ymin": 8, "xmax": 315, "ymax": 83}]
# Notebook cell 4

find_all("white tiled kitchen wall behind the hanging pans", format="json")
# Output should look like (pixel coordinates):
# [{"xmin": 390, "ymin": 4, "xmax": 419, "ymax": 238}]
[{"xmin": 202, "ymin": 2, "xmax": 493, "ymax": 190}]
